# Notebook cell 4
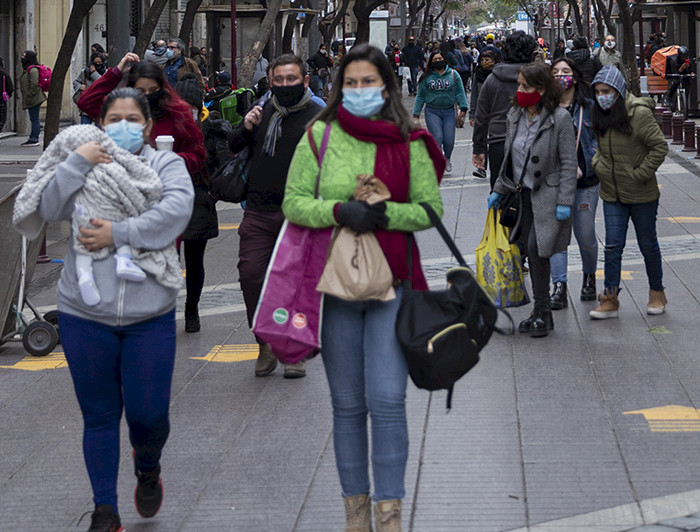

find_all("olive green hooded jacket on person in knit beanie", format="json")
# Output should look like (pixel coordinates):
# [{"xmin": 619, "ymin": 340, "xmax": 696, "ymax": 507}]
[{"xmin": 592, "ymin": 94, "xmax": 668, "ymax": 203}]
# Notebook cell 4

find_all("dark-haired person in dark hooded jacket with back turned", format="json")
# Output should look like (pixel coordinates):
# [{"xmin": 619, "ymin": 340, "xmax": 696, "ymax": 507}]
[{"xmin": 472, "ymin": 31, "xmax": 537, "ymax": 188}]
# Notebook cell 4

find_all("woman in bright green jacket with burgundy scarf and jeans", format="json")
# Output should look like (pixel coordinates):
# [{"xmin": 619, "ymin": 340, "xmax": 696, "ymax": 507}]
[{"xmin": 282, "ymin": 44, "xmax": 445, "ymax": 532}]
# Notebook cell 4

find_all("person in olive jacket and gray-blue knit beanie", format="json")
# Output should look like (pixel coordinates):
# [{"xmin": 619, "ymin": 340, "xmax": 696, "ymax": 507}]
[{"xmin": 590, "ymin": 66, "xmax": 668, "ymax": 320}]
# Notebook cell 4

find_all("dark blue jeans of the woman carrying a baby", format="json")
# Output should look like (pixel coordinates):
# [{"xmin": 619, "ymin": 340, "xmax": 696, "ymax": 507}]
[{"xmin": 58, "ymin": 309, "xmax": 175, "ymax": 512}]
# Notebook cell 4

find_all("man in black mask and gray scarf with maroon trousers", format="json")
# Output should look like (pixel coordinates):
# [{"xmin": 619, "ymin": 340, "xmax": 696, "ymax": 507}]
[{"xmin": 229, "ymin": 54, "xmax": 321, "ymax": 378}]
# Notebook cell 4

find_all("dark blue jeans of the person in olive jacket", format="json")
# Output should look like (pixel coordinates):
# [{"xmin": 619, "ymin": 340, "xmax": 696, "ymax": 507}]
[{"xmin": 603, "ymin": 200, "xmax": 664, "ymax": 290}]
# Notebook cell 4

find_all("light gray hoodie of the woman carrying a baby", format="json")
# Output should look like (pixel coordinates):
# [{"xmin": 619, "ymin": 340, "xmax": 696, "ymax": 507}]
[{"xmin": 39, "ymin": 145, "xmax": 194, "ymax": 326}]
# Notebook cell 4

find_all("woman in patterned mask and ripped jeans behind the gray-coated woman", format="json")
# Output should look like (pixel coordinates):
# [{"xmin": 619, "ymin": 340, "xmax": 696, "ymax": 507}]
[{"xmin": 549, "ymin": 57, "xmax": 600, "ymax": 310}]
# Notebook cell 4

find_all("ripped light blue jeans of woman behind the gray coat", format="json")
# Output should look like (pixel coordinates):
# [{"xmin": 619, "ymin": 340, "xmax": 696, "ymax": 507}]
[{"xmin": 549, "ymin": 183, "xmax": 600, "ymax": 283}]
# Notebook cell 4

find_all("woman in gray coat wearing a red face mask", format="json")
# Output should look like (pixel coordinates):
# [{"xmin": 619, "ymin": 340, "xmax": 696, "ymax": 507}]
[{"xmin": 488, "ymin": 63, "xmax": 578, "ymax": 337}]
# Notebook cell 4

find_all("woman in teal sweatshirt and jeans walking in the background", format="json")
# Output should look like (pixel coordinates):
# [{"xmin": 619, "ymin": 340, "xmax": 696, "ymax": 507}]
[{"xmin": 413, "ymin": 50, "xmax": 469, "ymax": 173}]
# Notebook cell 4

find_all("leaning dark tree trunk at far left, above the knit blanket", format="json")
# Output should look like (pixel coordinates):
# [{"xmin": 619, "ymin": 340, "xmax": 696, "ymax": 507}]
[{"xmin": 44, "ymin": 0, "xmax": 97, "ymax": 149}]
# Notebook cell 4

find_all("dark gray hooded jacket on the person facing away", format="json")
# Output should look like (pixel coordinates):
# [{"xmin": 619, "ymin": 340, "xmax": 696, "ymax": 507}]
[{"xmin": 472, "ymin": 63, "xmax": 523, "ymax": 154}]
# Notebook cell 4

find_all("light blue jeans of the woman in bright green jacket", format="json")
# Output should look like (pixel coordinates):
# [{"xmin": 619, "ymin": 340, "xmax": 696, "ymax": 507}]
[{"xmin": 321, "ymin": 288, "xmax": 408, "ymax": 501}]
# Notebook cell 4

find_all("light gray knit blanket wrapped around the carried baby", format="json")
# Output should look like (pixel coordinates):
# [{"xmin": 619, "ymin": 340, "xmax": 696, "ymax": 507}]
[{"xmin": 12, "ymin": 125, "xmax": 182, "ymax": 288}]
